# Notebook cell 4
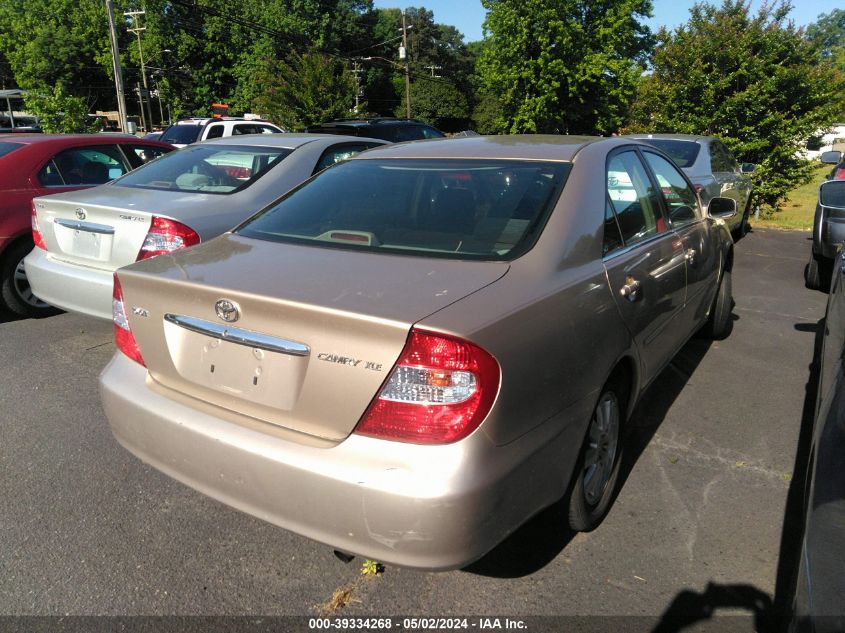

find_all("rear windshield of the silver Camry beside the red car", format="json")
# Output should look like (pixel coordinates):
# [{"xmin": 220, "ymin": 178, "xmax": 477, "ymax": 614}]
[{"xmin": 114, "ymin": 144, "xmax": 291, "ymax": 194}]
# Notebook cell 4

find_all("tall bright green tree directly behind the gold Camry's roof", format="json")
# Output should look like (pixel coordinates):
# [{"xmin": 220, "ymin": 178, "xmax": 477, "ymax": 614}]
[{"xmin": 479, "ymin": 0, "xmax": 652, "ymax": 134}]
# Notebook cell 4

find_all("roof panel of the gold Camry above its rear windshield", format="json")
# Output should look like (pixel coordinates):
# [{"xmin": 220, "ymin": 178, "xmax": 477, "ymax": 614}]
[{"xmin": 350, "ymin": 134, "xmax": 600, "ymax": 162}]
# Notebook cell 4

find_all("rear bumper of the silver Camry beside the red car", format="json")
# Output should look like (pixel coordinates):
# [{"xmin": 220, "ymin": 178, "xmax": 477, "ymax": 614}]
[{"xmin": 24, "ymin": 248, "xmax": 113, "ymax": 320}]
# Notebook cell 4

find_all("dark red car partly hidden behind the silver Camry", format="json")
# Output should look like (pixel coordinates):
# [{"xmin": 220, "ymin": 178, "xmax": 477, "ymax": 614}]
[{"xmin": 0, "ymin": 134, "xmax": 174, "ymax": 316}]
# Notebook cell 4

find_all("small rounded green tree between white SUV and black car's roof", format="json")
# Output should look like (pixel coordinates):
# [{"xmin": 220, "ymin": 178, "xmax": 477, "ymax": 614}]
[{"xmin": 255, "ymin": 53, "xmax": 355, "ymax": 130}]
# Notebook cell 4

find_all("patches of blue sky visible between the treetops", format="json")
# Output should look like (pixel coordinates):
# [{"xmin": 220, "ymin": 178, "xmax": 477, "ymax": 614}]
[{"xmin": 373, "ymin": 0, "xmax": 843, "ymax": 42}]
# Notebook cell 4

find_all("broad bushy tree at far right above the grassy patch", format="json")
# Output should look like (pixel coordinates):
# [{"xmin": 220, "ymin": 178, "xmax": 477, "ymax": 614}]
[{"xmin": 630, "ymin": 0, "xmax": 842, "ymax": 211}]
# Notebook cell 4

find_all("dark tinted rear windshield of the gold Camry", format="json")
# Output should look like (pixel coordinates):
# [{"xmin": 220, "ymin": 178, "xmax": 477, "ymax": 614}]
[{"xmin": 238, "ymin": 159, "xmax": 570, "ymax": 260}]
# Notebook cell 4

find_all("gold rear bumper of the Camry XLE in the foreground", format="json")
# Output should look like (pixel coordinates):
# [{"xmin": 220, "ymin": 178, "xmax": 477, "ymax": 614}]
[{"xmin": 100, "ymin": 352, "xmax": 580, "ymax": 570}]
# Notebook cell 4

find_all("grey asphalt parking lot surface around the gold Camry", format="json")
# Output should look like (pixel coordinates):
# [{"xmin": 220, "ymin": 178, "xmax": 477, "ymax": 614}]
[{"xmin": 0, "ymin": 230, "xmax": 826, "ymax": 631}]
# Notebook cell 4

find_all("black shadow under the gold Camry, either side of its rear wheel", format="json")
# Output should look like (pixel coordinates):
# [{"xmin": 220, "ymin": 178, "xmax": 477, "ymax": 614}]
[{"xmin": 464, "ymin": 334, "xmax": 716, "ymax": 578}]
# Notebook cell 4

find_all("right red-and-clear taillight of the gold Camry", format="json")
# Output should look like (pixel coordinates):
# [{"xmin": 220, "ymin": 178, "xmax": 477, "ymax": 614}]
[{"xmin": 355, "ymin": 328, "xmax": 500, "ymax": 444}]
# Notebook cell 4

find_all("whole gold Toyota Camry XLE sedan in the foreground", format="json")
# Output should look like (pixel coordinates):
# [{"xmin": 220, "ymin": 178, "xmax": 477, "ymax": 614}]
[{"xmin": 100, "ymin": 136, "xmax": 736, "ymax": 569}]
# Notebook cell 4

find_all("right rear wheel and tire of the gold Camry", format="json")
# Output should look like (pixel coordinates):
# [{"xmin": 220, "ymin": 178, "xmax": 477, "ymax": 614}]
[{"xmin": 569, "ymin": 380, "xmax": 627, "ymax": 532}]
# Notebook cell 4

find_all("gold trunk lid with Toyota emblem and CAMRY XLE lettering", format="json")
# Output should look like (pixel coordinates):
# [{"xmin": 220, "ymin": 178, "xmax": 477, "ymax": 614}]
[{"xmin": 120, "ymin": 235, "xmax": 508, "ymax": 441}]
